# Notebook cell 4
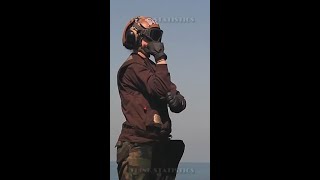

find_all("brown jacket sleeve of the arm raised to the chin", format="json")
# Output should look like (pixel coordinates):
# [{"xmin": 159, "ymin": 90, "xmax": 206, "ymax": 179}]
[{"xmin": 126, "ymin": 63, "xmax": 172, "ymax": 99}]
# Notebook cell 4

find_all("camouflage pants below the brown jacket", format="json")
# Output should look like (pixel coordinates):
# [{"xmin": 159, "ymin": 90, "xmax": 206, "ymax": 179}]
[{"xmin": 116, "ymin": 140, "xmax": 184, "ymax": 180}]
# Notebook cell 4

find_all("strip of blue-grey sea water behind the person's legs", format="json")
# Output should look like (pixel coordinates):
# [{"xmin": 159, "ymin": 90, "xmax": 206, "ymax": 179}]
[{"xmin": 110, "ymin": 161, "xmax": 210, "ymax": 180}]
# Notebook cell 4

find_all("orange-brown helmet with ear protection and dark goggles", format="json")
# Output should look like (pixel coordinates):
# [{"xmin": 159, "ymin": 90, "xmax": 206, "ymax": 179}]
[{"xmin": 122, "ymin": 16, "xmax": 163, "ymax": 49}]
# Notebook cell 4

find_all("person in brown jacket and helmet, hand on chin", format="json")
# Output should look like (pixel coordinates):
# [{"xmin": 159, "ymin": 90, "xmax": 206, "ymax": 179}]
[{"xmin": 116, "ymin": 16, "xmax": 186, "ymax": 180}]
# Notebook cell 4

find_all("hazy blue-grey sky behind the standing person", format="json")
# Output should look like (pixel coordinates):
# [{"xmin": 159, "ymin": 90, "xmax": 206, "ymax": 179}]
[{"xmin": 110, "ymin": 0, "xmax": 210, "ymax": 162}]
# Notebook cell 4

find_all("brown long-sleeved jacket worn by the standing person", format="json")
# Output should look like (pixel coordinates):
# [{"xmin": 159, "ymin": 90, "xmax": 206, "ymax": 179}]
[{"xmin": 117, "ymin": 53, "xmax": 185, "ymax": 143}]
